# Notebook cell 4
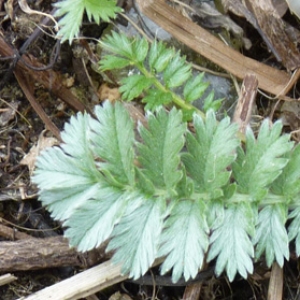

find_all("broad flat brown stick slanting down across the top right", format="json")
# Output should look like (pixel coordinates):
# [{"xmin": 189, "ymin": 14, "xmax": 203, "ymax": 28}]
[{"xmin": 136, "ymin": 0, "xmax": 290, "ymax": 95}]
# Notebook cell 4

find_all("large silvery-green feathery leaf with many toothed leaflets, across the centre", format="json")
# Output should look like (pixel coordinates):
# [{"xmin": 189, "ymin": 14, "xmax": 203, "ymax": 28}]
[{"xmin": 32, "ymin": 102, "xmax": 300, "ymax": 282}]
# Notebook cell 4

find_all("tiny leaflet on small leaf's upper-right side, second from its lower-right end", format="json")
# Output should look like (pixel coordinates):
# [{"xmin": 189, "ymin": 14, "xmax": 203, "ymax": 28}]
[{"xmin": 183, "ymin": 73, "xmax": 209, "ymax": 102}]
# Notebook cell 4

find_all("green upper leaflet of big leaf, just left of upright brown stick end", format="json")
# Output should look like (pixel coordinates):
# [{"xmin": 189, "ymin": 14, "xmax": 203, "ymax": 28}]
[{"xmin": 182, "ymin": 111, "xmax": 238, "ymax": 196}]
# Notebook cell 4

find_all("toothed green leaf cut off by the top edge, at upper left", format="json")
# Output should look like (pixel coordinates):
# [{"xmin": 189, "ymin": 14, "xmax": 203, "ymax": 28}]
[{"xmin": 54, "ymin": 0, "xmax": 122, "ymax": 44}]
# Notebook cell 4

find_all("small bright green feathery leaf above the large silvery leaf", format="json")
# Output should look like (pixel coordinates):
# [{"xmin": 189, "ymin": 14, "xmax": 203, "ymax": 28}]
[{"xmin": 100, "ymin": 32, "xmax": 221, "ymax": 119}]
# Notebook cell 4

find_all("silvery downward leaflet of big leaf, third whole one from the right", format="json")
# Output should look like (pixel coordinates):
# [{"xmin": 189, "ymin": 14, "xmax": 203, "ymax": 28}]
[{"xmin": 158, "ymin": 199, "xmax": 209, "ymax": 282}]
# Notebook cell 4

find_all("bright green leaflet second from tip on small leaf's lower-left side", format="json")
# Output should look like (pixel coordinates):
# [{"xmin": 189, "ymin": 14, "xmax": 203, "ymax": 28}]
[{"xmin": 119, "ymin": 74, "xmax": 153, "ymax": 101}]
